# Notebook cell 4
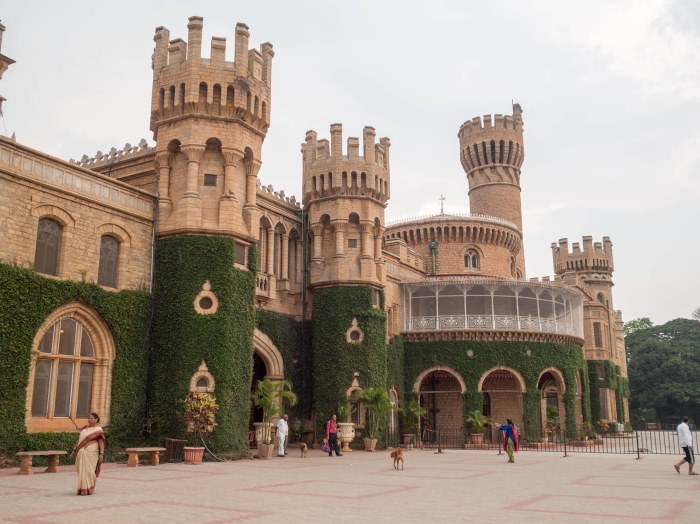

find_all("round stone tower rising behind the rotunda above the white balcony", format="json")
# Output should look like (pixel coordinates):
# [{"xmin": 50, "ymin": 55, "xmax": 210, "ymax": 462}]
[{"xmin": 457, "ymin": 104, "xmax": 525, "ymax": 277}]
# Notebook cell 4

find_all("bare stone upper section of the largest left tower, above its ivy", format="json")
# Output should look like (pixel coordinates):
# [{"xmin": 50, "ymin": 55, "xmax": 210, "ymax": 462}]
[{"xmin": 151, "ymin": 16, "xmax": 274, "ymax": 242}]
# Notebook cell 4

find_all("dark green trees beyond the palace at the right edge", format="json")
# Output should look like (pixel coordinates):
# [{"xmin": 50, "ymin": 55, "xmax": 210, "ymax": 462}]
[{"xmin": 625, "ymin": 318, "xmax": 700, "ymax": 422}]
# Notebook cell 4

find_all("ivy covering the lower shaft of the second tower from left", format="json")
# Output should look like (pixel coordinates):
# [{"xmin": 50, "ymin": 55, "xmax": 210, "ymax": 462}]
[{"xmin": 312, "ymin": 286, "xmax": 387, "ymax": 429}]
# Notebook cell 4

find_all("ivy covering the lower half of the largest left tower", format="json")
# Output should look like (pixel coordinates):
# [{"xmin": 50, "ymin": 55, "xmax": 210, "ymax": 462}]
[{"xmin": 149, "ymin": 235, "xmax": 257, "ymax": 457}]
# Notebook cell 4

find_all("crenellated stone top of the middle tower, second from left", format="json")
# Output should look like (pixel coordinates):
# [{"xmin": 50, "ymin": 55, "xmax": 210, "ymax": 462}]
[{"xmin": 301, "ymin": 124, "xmax": 391, "ymax": 205}]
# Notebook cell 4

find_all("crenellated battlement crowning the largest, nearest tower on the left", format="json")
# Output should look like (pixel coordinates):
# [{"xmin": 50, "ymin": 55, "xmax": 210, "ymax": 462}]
[{"xmin": 151, "ymin": 16, "xmax": 274, "ymax": 137}]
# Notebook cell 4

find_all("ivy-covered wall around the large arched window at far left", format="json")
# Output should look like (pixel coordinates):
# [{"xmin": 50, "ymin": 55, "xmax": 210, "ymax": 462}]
[{"xmin": 0, "ymin": 263, "xmax": 150, "ymax": 458}]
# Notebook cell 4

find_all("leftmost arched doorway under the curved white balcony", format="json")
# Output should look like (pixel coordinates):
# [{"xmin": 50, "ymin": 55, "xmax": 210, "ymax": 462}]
[{"xmin": 417, "ymin": 369, "xmax": 466, "ymax": 448}]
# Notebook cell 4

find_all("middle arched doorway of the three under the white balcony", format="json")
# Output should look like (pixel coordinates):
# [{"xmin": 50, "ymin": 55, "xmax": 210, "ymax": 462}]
[{"xmin": 479, "ymin": 368, "xmax": 525, "ymax": 440}]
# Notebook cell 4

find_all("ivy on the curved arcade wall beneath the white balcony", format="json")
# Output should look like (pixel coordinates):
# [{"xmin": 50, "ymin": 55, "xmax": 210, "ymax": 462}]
[{"xmin": 404, "ymin": 341, "xmax": 591, "ymax": 440}]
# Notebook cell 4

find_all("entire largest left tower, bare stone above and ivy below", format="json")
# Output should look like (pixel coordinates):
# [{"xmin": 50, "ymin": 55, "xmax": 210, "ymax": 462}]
[{"xmin": 149, "ymin": 16, "xmax": 273, "ymax": 455}]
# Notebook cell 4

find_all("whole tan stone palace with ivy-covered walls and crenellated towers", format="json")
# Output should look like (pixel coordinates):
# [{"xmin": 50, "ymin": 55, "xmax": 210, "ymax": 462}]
[{"xmin": 0, "ymin": 16, "xmax": 628, "ymax": 456}]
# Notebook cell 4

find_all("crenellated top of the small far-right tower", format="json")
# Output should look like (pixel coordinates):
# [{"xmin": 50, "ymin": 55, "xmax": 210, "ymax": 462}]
[{"xmin": 552, "ymin": 236, "xmax": 614, "ymax": 276}]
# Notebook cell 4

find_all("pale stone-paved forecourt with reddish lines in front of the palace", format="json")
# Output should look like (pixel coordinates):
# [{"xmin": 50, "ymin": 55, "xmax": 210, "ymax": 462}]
[{"xmin": 0, "ymin": 448, "xmax": 700, "ymax": 524}]
